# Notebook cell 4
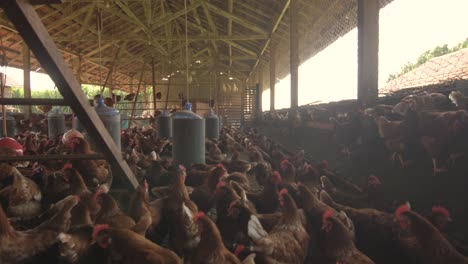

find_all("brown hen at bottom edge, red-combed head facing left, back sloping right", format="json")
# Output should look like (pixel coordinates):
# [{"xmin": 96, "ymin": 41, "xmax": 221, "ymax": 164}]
[{"xmin": 93, "ymin": 225, "xmax": 183, "ymax": 264}]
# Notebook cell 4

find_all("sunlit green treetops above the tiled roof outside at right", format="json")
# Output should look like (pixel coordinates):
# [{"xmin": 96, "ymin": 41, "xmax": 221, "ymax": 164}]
[{"xmin": 387, "ymin": 38, "xmax": 468, "ymax": 82}]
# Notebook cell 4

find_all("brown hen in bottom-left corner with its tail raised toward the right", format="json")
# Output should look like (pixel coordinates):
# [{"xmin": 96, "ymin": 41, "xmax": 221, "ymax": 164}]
[{"xmin": 0, "ymin": 196, "xmax": 78, "ymax": 264}]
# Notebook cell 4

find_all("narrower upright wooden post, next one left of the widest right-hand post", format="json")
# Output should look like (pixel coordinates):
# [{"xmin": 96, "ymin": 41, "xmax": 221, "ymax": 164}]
[{"xmin": 289, "ymin": 0, "xmax": 299, "ymax": 108}]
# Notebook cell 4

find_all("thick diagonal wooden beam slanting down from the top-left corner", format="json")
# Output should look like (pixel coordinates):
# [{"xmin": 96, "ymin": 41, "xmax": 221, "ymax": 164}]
[{"xmin": 3, "ymin": 0, "xmax": 139, "ymax": 188}]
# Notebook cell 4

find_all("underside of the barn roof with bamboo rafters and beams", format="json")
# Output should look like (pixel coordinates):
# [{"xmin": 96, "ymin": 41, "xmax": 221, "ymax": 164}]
[{"xmin": 0, "ymin": 0, "xmax": 392, "ymax": 93}]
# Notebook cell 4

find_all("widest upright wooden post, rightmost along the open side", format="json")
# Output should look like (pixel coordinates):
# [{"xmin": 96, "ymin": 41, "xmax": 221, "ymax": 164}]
[{"xmin": 358, "ymin": 0, "xmax": 379, "ymax": 107}]
